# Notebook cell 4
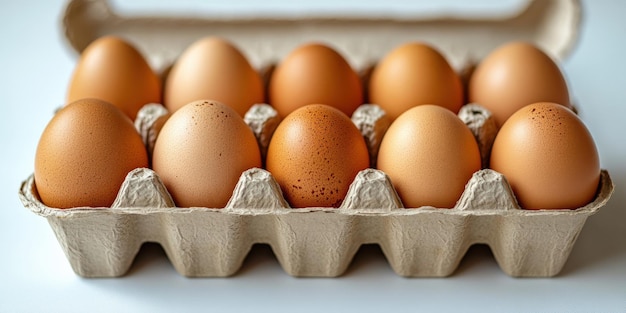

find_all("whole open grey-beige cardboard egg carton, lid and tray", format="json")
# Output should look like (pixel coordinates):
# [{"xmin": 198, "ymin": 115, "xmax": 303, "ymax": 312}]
[{"xmin": 19, "ymin": 0, "xmax": 613, "ymax": 277}]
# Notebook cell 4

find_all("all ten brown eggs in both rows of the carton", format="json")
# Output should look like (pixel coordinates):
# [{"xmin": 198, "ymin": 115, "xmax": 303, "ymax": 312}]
[{"xmin": 35, "ymin": 37, "xmax": 600, "ymax": 209}]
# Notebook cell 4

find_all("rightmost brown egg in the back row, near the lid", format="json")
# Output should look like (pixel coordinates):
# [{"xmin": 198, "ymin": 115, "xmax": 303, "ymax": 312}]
[{"xmin": 468, "ymin": 42, "xmax": 570, "ymax": 126}]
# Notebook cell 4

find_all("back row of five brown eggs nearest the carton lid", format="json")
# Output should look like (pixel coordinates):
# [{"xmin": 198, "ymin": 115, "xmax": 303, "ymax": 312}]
[{"xmin": 68, "ymin": 36, "xmax": 570, "ymax": 125}]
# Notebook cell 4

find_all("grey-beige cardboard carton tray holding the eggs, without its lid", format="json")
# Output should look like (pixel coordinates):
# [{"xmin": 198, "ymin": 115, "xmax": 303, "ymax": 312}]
[{"xmin": 19, "ymin": 104, "xmax": 613, "ymax": 277}]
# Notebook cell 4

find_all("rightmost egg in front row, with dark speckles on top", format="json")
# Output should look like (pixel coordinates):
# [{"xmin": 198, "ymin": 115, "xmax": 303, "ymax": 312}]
[{"xmin": 490, "ymin": 102, "xmax": 600, "ymax": 209}]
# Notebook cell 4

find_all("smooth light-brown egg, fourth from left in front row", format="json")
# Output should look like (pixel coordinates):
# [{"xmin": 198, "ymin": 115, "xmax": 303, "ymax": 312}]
[{"xmin": 378, "ymin": 105, "xmax": 481, "ymax": 208}]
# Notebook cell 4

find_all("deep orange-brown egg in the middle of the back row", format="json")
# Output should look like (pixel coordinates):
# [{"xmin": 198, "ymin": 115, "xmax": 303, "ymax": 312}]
[{"xmin": 268, "ymin": 43, "xmax": 363, "ymax": 117}]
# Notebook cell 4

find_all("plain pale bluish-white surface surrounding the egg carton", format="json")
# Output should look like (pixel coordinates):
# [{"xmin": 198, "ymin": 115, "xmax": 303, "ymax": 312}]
[{"xmin": 0, "ymin": 0, "xmax": 626, "ymax": 312}]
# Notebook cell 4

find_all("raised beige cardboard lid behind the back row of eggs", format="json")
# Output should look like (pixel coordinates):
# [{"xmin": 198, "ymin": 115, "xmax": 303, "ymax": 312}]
[{"xmin": 63, "ymin": 0, "xmax": 581, "ymax": 72}]
